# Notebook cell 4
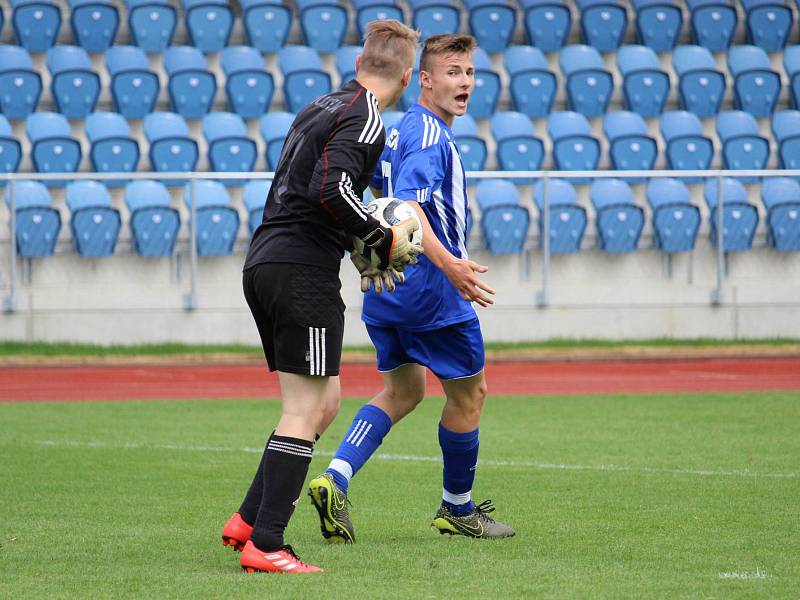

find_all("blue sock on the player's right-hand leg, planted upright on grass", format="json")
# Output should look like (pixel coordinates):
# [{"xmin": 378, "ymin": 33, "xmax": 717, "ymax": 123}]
[{"xmin": 439, "ymin": 423, "xmax": 479, "ymax": 515}]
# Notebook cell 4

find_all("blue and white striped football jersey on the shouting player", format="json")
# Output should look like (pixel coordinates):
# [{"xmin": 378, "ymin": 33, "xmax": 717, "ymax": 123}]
[{"xmin": 361, "ymin": 104, "xmax": 476, "ymax": 331}]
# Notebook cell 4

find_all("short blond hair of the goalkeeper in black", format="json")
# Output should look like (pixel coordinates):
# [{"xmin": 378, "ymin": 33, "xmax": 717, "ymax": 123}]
[{"xmin": 361, "ymin": 19, "xmax": 419, "ymax": 79}]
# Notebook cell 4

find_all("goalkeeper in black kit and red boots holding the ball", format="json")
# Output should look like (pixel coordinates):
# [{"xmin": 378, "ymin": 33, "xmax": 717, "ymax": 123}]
[{"xmin": 216, "ymin": 21, "xmax": 422, "ymax": 573}]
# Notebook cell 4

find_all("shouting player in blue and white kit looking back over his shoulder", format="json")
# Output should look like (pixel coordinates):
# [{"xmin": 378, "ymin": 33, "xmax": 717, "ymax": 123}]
[{"xmin": 309, "ymin": 35, "xmax": 515, "ymax": 542}]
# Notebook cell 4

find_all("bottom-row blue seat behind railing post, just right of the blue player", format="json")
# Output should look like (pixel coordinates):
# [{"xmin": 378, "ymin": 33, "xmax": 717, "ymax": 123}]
[{"xmin": 533, "ymin": 179, "xmax": 587, "ymax": 254}]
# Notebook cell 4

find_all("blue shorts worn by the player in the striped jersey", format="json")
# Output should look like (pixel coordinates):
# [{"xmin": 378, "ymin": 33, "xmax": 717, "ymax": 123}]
[{"xmin": 367, "ymin": 318, "xmax": 484, "ymax": 379}]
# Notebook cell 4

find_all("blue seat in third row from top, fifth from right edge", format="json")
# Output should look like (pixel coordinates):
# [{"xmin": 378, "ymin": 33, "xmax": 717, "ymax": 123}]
[{"xmin": 547, "ymin": 111, "xmax": 600, "ymax": 177}]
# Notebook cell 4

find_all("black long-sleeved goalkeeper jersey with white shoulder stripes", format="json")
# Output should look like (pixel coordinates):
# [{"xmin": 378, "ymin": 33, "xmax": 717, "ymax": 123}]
[{"xmin": 244, "ymin": 80, "xmax": 386, "ymax": 271}]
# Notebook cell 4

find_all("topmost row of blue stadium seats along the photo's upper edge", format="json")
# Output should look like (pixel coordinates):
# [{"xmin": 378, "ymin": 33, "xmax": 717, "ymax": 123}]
[{"xmin": 0, "ymin": 0, "xmax": 794, "ymax": 53}]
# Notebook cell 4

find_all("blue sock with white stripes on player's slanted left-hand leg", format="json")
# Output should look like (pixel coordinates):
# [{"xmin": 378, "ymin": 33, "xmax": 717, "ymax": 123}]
[{"xmin": 325, "ymin": 404, "xmax": 392, "ymax": 493}]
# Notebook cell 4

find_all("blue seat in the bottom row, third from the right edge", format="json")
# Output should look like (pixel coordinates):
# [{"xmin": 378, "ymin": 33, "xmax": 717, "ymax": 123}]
[{"xmin": 647, "ymin": 177, "xmax": 700, "ymax": 254}]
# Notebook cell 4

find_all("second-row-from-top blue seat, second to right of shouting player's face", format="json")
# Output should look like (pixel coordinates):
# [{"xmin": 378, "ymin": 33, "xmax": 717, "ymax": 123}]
[{"xmin": 503, "ymin": 46, "xmax": 558, "ymax": 117}]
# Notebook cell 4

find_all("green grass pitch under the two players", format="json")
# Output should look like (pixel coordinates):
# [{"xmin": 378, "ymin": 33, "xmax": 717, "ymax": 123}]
[{"xmin": 0, "ymin": 393, "xmax": 800, "ymax": 600}]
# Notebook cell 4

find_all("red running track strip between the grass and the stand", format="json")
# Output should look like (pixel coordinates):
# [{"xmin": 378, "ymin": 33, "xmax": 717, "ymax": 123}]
[{"xmin": 0, "ymin": 358, "xmax": 800, "ymax": 402}]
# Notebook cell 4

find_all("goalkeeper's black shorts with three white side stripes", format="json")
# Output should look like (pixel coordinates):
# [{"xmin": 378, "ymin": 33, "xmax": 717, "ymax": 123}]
[{"xmin": 243, "ymin": 263, "xmax": 344, "ymax": 376}]
